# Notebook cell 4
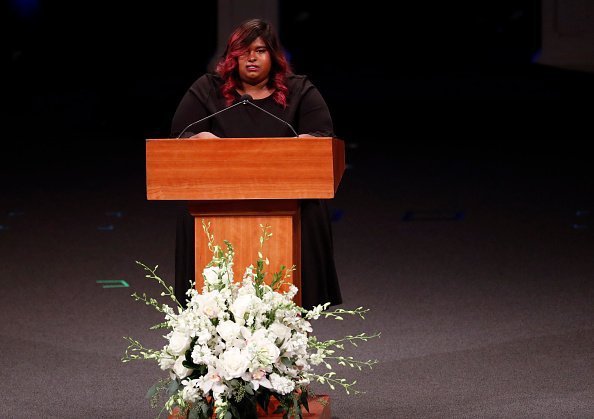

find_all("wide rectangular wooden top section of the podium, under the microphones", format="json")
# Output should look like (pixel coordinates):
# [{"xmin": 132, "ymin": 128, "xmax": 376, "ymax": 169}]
[{"xmin": 146, "ymin": 137, "xmax": 345, "ymax": 201}]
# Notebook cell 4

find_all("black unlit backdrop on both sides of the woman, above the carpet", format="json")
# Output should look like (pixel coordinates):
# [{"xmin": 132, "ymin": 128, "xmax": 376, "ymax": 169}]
[{"xmin": 2, "ymin": 0, "xmax": 594, "ymax": 166}]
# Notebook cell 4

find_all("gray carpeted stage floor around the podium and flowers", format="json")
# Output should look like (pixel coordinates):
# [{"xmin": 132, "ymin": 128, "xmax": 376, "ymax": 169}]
[{"xmin": 0, "ymin": 142, "xmax": 594, "ymax": 418}]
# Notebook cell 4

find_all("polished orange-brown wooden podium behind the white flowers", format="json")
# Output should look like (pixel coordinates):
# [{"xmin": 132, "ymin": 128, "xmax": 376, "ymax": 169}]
[{"xmin": 146, "ymin": 137, "xmax": 345, "ymax": 305}]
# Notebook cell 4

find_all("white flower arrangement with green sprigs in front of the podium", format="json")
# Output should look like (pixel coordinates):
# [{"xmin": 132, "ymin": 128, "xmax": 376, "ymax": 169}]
[{"xmin": 122, "ymin": 221, "xmax": 380, "ymax": 419}]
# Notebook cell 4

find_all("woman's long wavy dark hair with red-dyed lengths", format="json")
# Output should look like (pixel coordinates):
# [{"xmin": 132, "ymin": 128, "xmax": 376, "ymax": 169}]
[{"xmin": 215, "ymin": 19, "xmax": 291, "ymax": 107}]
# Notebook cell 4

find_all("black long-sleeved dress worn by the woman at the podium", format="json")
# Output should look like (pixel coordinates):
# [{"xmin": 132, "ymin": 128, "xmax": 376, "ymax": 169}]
[{"xmin": 171, "ymin": 74, "xmax": 342, "ymax": 308}]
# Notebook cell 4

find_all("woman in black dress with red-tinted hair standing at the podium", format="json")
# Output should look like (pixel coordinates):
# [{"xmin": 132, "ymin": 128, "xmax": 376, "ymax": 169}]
[{"xmin": 171, "ymin": 19, "xmax": 342, "ymax": 308}]
